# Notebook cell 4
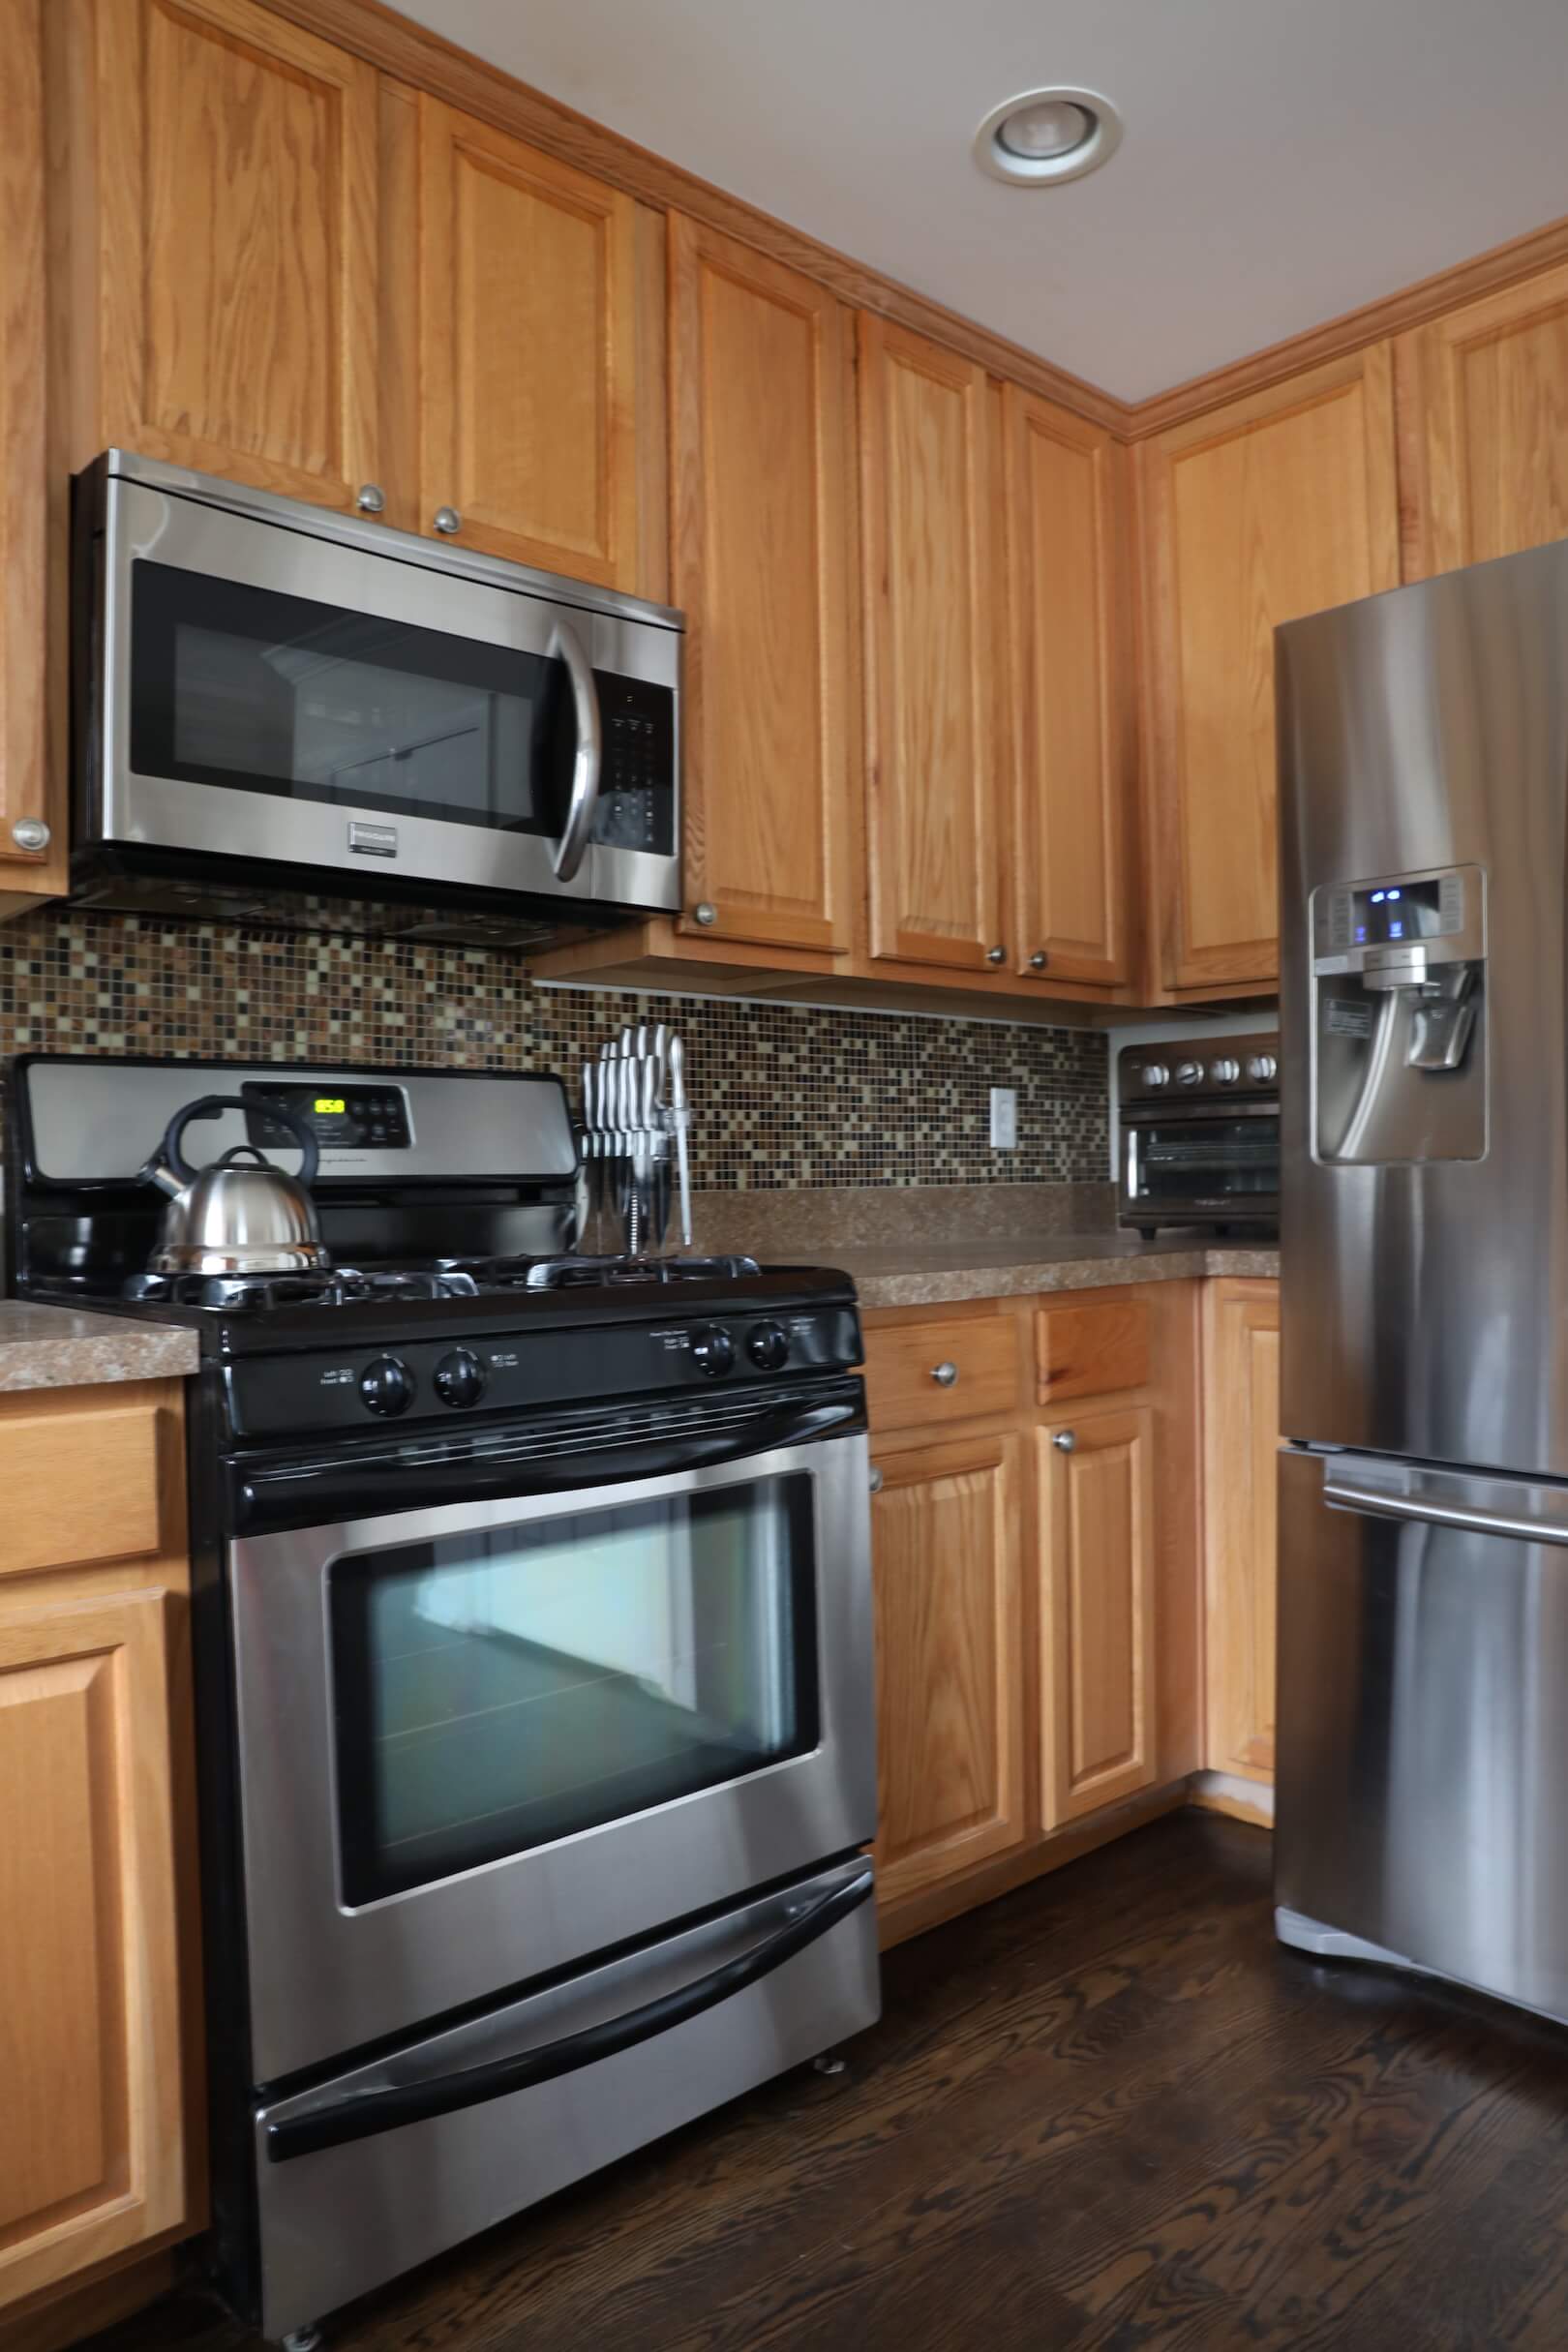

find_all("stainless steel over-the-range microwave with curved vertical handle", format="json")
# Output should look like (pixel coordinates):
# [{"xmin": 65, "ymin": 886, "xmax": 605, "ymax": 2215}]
[{"xmin": 71, "ymin": 449, "xmax": 681, "ymax": 943}]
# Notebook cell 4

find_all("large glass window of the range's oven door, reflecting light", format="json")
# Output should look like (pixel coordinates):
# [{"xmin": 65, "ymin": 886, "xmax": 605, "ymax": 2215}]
[{"xmin": 327, "ymin": 1472, "xmax": 818, "ymax": 1908}]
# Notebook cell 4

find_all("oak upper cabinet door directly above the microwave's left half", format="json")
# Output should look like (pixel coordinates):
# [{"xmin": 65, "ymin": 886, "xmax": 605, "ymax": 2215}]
[{"xmin": 63, "ymin": 0, "xmax": 378, "ymax": 505}]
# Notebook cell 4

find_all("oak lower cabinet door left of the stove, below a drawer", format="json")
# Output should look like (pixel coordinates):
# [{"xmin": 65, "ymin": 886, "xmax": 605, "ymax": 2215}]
[{"xmin": 0, "ymin": 1592, "xmax": 186, "ymax": 2305}]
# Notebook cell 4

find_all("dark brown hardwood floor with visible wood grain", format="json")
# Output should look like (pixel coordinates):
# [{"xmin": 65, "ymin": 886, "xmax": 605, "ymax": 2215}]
[{"xmin": 82, "ymin": 1814, "xmax": 1568, "ymax": 2352}]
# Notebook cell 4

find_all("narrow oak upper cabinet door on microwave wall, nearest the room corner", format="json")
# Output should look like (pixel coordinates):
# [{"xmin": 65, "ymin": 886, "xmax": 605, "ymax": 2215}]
[{"xmin": 1002, "ymin": 383, "xmax": 1133, "ymax": 985}]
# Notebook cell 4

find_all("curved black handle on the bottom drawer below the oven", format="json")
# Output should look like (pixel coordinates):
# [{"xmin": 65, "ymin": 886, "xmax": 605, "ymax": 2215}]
[{"xmin": 265, "ymin": 1863, "xmax": 875, "ymax": 2164}]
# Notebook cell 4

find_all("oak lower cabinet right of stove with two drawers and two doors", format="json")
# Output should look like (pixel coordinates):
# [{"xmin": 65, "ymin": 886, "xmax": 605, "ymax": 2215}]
[{"xmin": 865, "ymin": 1282, "xmax": 1204, "ymax": 1943}]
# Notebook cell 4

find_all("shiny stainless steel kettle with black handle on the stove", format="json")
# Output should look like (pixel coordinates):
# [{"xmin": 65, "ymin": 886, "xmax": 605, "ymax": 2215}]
[{"xmin": 141, "ymin": 1094, "xmax": 331, "ymax": 1275}]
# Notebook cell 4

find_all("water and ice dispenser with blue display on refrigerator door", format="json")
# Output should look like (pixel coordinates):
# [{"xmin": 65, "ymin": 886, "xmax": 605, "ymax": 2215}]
[{"xmin": 1312, "ymin": 865, "xmax": 1486, "ymax": 1166}]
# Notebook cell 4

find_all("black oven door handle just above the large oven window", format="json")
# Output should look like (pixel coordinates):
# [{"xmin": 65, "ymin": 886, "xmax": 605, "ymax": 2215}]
[{"xmin": 230, "ymin": 1397, "xmax": 865, "ymax": 1536}]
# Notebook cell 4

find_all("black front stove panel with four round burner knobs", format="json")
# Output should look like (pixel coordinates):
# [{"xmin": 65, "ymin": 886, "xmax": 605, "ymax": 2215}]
[{"xmin": 226, "ymin": 1303, "xmax": 862, "ymax": 1442}]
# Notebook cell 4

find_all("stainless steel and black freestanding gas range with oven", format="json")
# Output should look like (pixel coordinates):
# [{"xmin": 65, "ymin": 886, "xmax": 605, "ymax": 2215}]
[{"xmin": 7, "ymin": 1056, "xmax": 879, "ymax": 2336}]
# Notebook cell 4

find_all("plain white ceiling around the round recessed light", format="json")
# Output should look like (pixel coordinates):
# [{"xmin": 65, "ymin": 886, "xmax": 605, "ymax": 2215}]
[{"xmin": 395, "ymin": 0, "xmax": 1568, "ymax": 400}]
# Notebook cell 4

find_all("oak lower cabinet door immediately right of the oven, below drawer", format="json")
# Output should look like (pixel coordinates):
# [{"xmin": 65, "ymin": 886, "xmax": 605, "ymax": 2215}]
[{"xmin": 872, "ymin": 1437, "xmax": 1025, "ymax": 1903}]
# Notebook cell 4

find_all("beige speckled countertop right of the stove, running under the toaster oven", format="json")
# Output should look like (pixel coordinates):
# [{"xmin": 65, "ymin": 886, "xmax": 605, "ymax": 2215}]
[{"xmin": 816, "ymin": 1232, "xmax": 1279, "ymax": 1308}]
